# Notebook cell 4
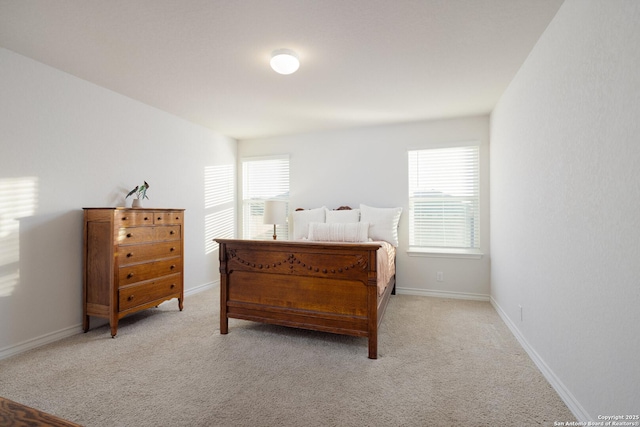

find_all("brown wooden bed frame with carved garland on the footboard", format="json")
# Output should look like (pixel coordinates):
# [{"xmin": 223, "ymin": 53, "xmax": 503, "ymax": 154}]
[{"xmin": 215, "ymin": 239, "xmax": 395, "ymax": 359}]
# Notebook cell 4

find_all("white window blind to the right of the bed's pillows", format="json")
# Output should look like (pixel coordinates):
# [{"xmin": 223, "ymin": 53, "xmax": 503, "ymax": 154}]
[{"xmin": 409, "ymin": 145, "xmax": 480, "ymax": 250}]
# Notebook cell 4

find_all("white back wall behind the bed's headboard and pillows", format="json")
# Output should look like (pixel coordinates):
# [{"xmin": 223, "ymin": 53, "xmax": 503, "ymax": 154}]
[{"xmin": 238, "ymin": 116, "xmax": 490, "ymax": 299}]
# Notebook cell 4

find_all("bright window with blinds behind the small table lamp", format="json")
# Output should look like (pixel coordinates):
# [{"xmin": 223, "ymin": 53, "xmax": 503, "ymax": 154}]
[{"xmin": 242, "ymin": 156, "xmax": 289, "ymax": 240}]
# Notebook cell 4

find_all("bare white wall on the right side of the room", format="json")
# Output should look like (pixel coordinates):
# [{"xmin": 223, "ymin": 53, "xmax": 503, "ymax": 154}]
[{"xmin": 490, "ymin": 0, "xmax": 640, "ymax": 421}]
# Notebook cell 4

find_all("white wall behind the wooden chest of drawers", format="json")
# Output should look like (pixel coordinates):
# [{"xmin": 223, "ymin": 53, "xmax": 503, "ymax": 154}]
[{"xmin": 0, "ymin": 49, "xmax": 237, "ymax": 357}]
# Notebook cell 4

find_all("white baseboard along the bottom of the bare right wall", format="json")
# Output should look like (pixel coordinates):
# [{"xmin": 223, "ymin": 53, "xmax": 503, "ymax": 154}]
[{"xmin": 490, "ymin": 298, "xmax": 593, "ymax": 423}]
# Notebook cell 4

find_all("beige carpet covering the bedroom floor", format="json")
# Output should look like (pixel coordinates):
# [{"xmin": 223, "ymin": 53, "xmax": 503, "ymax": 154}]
[{"xmin": 0, "ymin": 288, "xmax": 575, "ymax": 427}]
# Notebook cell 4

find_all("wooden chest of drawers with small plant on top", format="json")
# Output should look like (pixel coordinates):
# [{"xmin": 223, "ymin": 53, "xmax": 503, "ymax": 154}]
[{"xmin": 82, "ymin": 208, "xmax": 184, "ymax": 337}]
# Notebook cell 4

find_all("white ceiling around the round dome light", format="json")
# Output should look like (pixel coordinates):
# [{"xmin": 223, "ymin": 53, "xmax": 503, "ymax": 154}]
[{"xmin": 0, "ymin": 0, "xmax": 562, "ymax": 139}]
